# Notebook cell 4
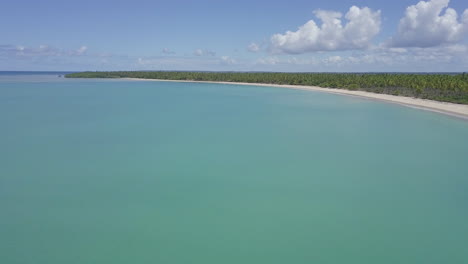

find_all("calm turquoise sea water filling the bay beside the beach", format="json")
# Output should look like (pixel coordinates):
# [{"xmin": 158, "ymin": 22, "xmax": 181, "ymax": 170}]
[{"xmin": 0, "ymin": 74, "xmax": 468, "ymax": 264}]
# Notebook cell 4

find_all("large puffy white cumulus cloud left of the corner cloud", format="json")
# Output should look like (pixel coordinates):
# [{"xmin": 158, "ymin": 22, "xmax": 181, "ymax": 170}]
[{"xmin": 271, "ymin": 6, "xmax": 380, "ymax": 54}]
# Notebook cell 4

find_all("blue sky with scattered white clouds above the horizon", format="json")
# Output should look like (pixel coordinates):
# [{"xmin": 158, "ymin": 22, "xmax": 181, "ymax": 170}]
[{"xmin": 0, "ymin": 0, "xmax": 468, "ymax": 72}]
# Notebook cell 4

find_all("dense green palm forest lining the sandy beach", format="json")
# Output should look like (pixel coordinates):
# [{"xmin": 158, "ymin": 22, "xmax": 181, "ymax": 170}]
[{"xmin": 65, "ymin": 71, "xmax": 468, "ymax": 104}]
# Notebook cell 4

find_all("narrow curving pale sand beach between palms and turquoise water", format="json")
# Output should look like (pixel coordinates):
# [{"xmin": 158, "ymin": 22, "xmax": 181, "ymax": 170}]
[{"xmin": 120, "ymin": 78, "xmax": 468, "ymax": 121}]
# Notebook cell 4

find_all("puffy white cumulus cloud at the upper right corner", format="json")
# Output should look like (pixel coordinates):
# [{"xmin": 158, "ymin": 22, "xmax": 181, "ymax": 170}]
[{"xmin": 389, "ymin": 0, "xmax": 468, "ymax": 48}]
